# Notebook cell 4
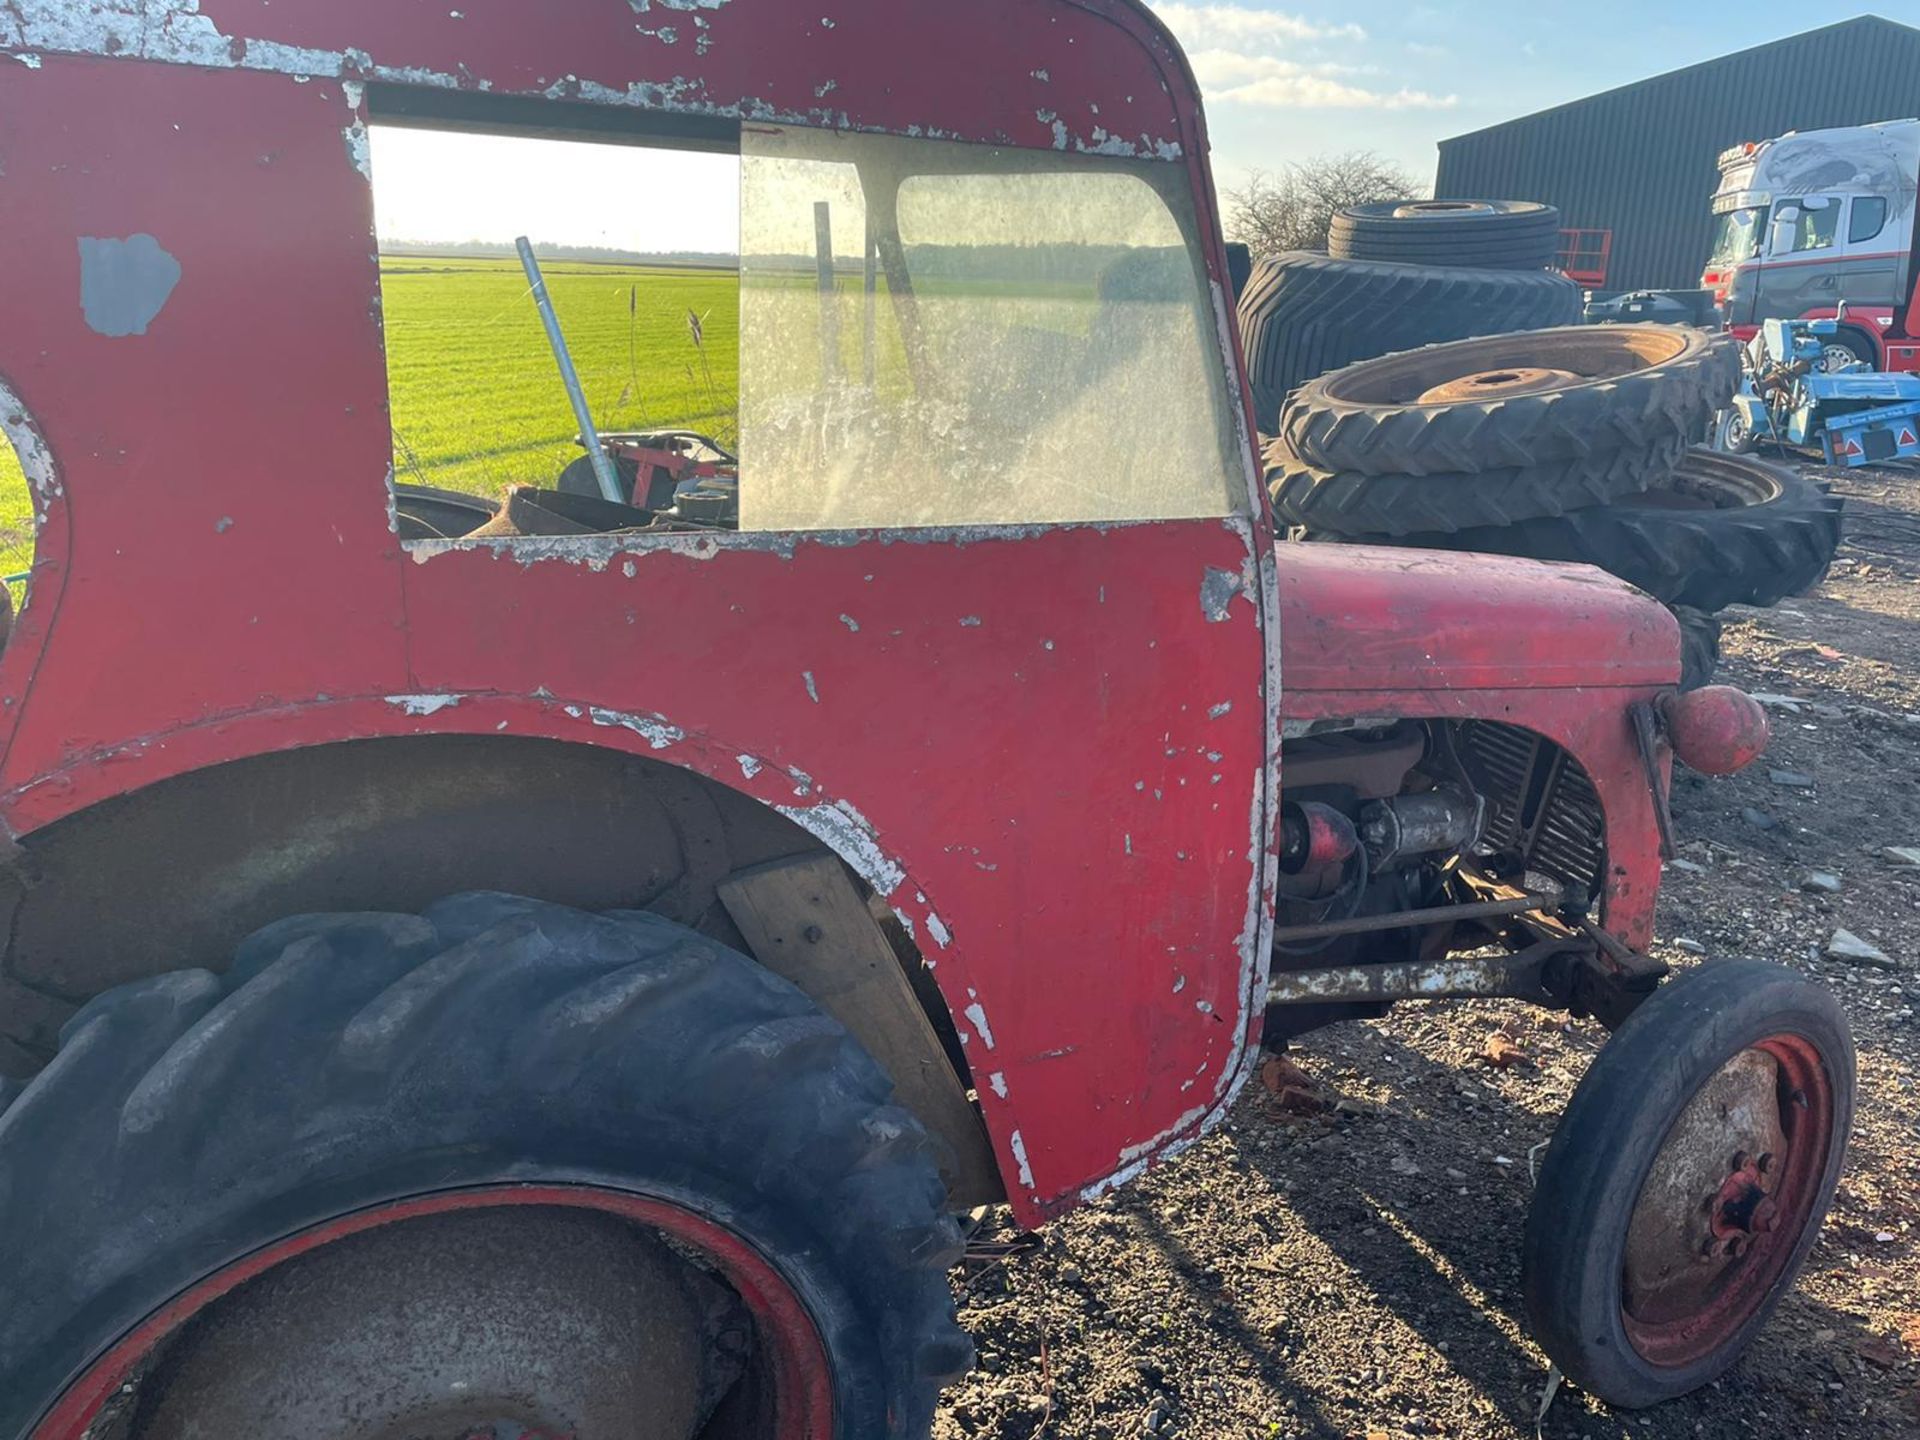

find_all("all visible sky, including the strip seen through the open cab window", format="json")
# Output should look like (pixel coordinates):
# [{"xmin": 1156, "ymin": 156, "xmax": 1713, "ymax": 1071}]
[{"xmin": 372, "ymin": 0, "xmax": 1920, "ymax": 250}]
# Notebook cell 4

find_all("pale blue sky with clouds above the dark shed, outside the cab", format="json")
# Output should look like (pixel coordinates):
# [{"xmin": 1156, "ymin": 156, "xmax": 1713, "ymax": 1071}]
[{"xmin": 1175, "ymin": 0, "xmax": 1920, "ymax": 186}]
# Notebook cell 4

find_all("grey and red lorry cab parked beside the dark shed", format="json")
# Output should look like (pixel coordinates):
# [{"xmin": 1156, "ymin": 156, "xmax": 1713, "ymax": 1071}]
[{"xmin": 1701, "ymin": 119, "xmax": 1920, "ymax": 371}]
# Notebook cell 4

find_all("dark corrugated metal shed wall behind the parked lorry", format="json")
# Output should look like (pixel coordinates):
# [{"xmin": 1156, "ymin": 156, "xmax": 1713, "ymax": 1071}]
[{"xmin": 1434, "ymin": 17, "xmax": 1920, "ymax": 290}]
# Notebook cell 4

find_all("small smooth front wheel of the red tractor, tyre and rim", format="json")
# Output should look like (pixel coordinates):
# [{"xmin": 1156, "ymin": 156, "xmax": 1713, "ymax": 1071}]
[{"xmin": 1521, "ymin": 960, "xmax": 1855, "ymax": 1409}]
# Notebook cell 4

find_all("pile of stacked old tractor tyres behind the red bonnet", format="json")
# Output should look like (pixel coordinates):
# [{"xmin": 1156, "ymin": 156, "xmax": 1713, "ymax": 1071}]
[{"xmin": 1240, "ymin": 205, "xmax": 1841, "ymax": 685}]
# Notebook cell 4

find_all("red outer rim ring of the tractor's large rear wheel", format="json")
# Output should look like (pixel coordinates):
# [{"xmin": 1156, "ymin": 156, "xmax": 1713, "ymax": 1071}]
[{"xmin": 31, "ymin": 1185, "xmax": 835, "ymax": 1440}]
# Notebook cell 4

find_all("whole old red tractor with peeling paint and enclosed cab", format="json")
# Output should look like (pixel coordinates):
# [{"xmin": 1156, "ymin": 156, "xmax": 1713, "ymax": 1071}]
[{"xmin": 0, "ymin": 0, "xmax": 1853, "ymax": 1440}]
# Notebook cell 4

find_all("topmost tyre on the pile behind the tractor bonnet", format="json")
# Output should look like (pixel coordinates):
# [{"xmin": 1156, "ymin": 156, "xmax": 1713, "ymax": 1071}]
[{"xmin": 1327, "ymin": 200, "xmax": 1561, "ymax": 271}]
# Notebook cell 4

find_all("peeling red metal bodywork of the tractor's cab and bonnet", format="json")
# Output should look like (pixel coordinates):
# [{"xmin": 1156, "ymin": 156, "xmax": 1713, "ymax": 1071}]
[{"xmin": 0, "ymin": 0, "xmax": 1678, "ymax": 1223}]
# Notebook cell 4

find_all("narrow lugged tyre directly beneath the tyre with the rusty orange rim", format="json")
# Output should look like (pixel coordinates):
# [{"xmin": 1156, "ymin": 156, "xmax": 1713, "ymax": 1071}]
[{"xmin": 1265, "ymin": 436, "xmax": 1686, "ymax": 549}]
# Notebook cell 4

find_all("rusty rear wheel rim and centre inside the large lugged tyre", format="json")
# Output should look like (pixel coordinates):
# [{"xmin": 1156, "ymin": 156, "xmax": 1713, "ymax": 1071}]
[{"xmin": 33, "ymin": 1187, "xmax": 833, "ymax": 1440}]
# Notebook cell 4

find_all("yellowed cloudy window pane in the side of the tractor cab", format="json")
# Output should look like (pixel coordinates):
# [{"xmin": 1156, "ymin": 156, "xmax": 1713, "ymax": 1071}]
[{"xmin": 739, "ymin": 127, "xmax": 1246, "ymax": 530}]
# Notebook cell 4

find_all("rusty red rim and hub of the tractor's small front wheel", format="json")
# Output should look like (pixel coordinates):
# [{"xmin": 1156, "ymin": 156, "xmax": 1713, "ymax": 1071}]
[{"xmin": 1620, "ymin": 1035, "xmax": 1834, "ymax": 1367}]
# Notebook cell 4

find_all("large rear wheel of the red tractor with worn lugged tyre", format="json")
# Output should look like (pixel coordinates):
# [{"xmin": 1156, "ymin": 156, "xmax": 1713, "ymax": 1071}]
[{"xmin": 0, "ymin": 895, "xmax": 972, "ymax": 1440}]
